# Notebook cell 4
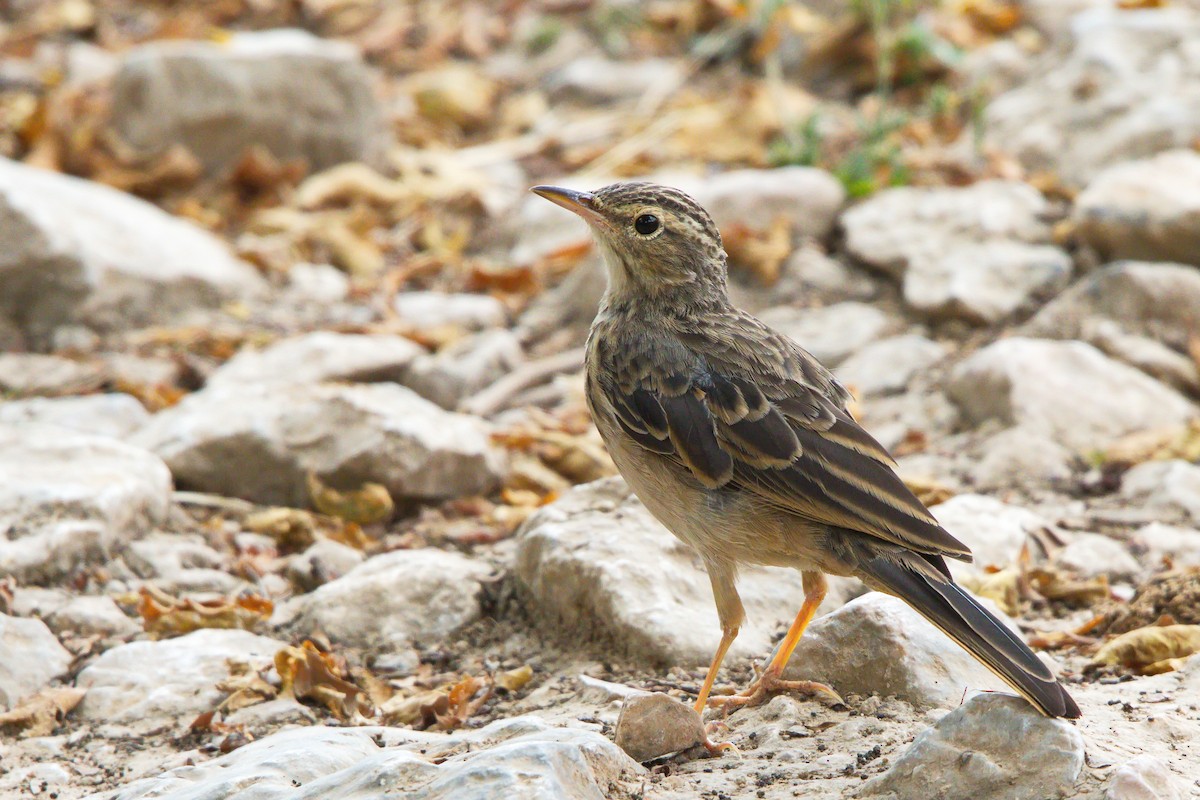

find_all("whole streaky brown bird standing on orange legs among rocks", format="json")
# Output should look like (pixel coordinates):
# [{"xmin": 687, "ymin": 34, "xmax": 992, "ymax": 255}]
[{"xmin": 532, "ymin": 181, "xmax": 1080, "ymax": 750}]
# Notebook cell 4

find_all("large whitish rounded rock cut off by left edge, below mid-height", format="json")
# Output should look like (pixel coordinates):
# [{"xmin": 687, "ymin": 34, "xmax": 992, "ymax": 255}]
[{"xmin": 0, "ymin": 423, "xmax": 170, "ymax": 582}]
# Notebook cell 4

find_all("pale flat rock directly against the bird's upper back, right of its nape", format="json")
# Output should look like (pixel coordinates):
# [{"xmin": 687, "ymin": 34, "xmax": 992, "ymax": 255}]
[{"xmin": 761, "ymin": 302, "xmax": 895, "ymax": 367}]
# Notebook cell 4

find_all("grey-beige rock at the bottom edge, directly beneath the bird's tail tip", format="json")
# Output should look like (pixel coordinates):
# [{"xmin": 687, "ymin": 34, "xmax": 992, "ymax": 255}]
[{"xmin": 863, "ymin": 694, "xmax": 1084, "ymax": 800}]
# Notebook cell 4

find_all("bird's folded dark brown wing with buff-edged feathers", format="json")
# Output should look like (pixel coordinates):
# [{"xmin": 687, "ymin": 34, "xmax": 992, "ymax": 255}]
[{"xmin": 598, "ymin": 314, "xmax": 971, "ymax": 560}]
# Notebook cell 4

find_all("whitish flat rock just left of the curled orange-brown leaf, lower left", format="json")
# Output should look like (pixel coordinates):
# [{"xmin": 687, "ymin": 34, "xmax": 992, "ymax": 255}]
[{"xmin": 76, "ymin": 628, "xmax": 287, "ymax": 726}]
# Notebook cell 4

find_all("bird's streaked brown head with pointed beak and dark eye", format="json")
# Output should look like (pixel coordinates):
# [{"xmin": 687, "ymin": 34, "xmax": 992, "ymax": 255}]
[{"xmin": 532, "ymin": 184, "xmax": 726, "ymax": 299}]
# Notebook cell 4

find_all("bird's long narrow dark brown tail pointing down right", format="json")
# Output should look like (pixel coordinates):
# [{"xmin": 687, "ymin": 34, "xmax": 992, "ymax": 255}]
[{"xmin": 854, "ymin": 546, "xmax": 1080, "ymax": 720}]
